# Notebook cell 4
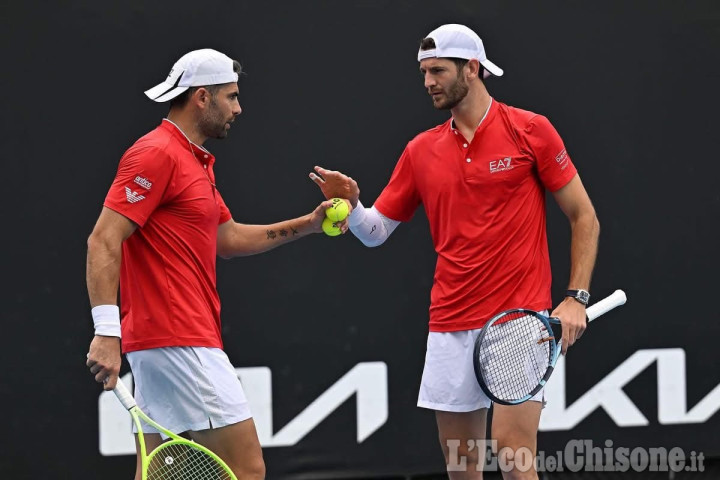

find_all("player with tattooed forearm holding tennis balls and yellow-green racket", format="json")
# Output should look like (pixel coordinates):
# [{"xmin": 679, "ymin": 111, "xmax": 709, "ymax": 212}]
[{"xmin": 87, "ymin": 49, "xmax": 347, "ymax": 480}]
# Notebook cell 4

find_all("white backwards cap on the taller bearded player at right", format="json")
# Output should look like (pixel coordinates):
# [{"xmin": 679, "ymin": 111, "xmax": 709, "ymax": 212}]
[{"xmin": 418, "ymin": 23, "xmax": 503, "ymax": 78}]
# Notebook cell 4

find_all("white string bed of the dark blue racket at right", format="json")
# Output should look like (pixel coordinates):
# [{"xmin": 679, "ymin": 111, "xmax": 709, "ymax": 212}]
[{"xmin": 479, "ymin": 312, "xmax": 553, "ymax": 401}]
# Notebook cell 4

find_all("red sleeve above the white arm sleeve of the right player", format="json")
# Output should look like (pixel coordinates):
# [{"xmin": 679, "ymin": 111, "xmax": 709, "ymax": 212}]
[{"xmin": 374, "ymin": 145, "xmax": 420, "ymax": 222}]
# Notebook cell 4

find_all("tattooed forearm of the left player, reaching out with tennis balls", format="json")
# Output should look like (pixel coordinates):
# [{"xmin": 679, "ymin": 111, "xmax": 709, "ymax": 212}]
[{"xmin": 218, "ymin": 215, "xmax": 317, "ymax": 258}]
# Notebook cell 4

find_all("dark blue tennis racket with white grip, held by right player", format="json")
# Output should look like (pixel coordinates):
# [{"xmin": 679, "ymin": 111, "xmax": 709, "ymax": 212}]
[{"xmin": 473, "ymin": 290, "xmax": 627, "ymax": 405}]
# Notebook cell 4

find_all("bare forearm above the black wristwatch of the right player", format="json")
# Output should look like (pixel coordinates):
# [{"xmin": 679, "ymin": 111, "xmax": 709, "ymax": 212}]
[{"xmin": 568, "ymin": 210, "xmax": 600, "ymax": 290}]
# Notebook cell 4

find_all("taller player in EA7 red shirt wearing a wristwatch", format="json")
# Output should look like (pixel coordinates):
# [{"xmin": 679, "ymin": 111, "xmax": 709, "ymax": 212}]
[{"xmin": 310, "ymin": 24, "xmax": 600, "ymax": 479}]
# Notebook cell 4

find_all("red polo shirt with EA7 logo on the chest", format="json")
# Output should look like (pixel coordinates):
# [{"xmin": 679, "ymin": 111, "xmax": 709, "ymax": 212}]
[{"xmin": 375, "ymin": 100, "xmax": 577, "ymax": 332}]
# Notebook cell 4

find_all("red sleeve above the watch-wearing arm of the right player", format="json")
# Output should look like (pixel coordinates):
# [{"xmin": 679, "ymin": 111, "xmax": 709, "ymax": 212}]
[{"xmin": 525, "ymin": 115, "xmax": 577, "ymax": 192}]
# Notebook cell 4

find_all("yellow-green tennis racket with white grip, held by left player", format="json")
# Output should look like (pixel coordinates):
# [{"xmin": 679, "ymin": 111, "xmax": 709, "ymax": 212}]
[{"xmin": 113, "ymin": 378, "xmax": 237, "ymax": 480}]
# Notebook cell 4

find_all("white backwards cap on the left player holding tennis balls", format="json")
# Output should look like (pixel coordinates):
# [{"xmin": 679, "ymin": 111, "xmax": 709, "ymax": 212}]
[{"xmin": 145, "ymin": 48, "xmax": 238, "ymax": 102}]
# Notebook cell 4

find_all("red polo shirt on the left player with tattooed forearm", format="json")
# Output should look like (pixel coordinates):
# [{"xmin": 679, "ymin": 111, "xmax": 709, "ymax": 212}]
[{"xmin": 104, "ymin": 120, "xmax": 231, "ymax": 352}]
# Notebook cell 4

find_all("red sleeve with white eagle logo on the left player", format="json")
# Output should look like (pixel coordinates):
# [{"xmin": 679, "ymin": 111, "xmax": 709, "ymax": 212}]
[{"xmin": 104, "ymin": 146, "xmax": 175, "ymax": 227}]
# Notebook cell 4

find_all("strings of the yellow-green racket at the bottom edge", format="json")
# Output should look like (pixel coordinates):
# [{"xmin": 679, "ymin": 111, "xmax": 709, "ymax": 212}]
[{"xmin": 147, "ymin": 443, "xmax": 232, "ymax": 480}]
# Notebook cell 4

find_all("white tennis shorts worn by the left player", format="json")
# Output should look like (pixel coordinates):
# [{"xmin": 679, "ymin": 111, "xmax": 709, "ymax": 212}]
[{"xmin": 127, "ymin": 347, "xmax": 252, "ymax": 433}]
